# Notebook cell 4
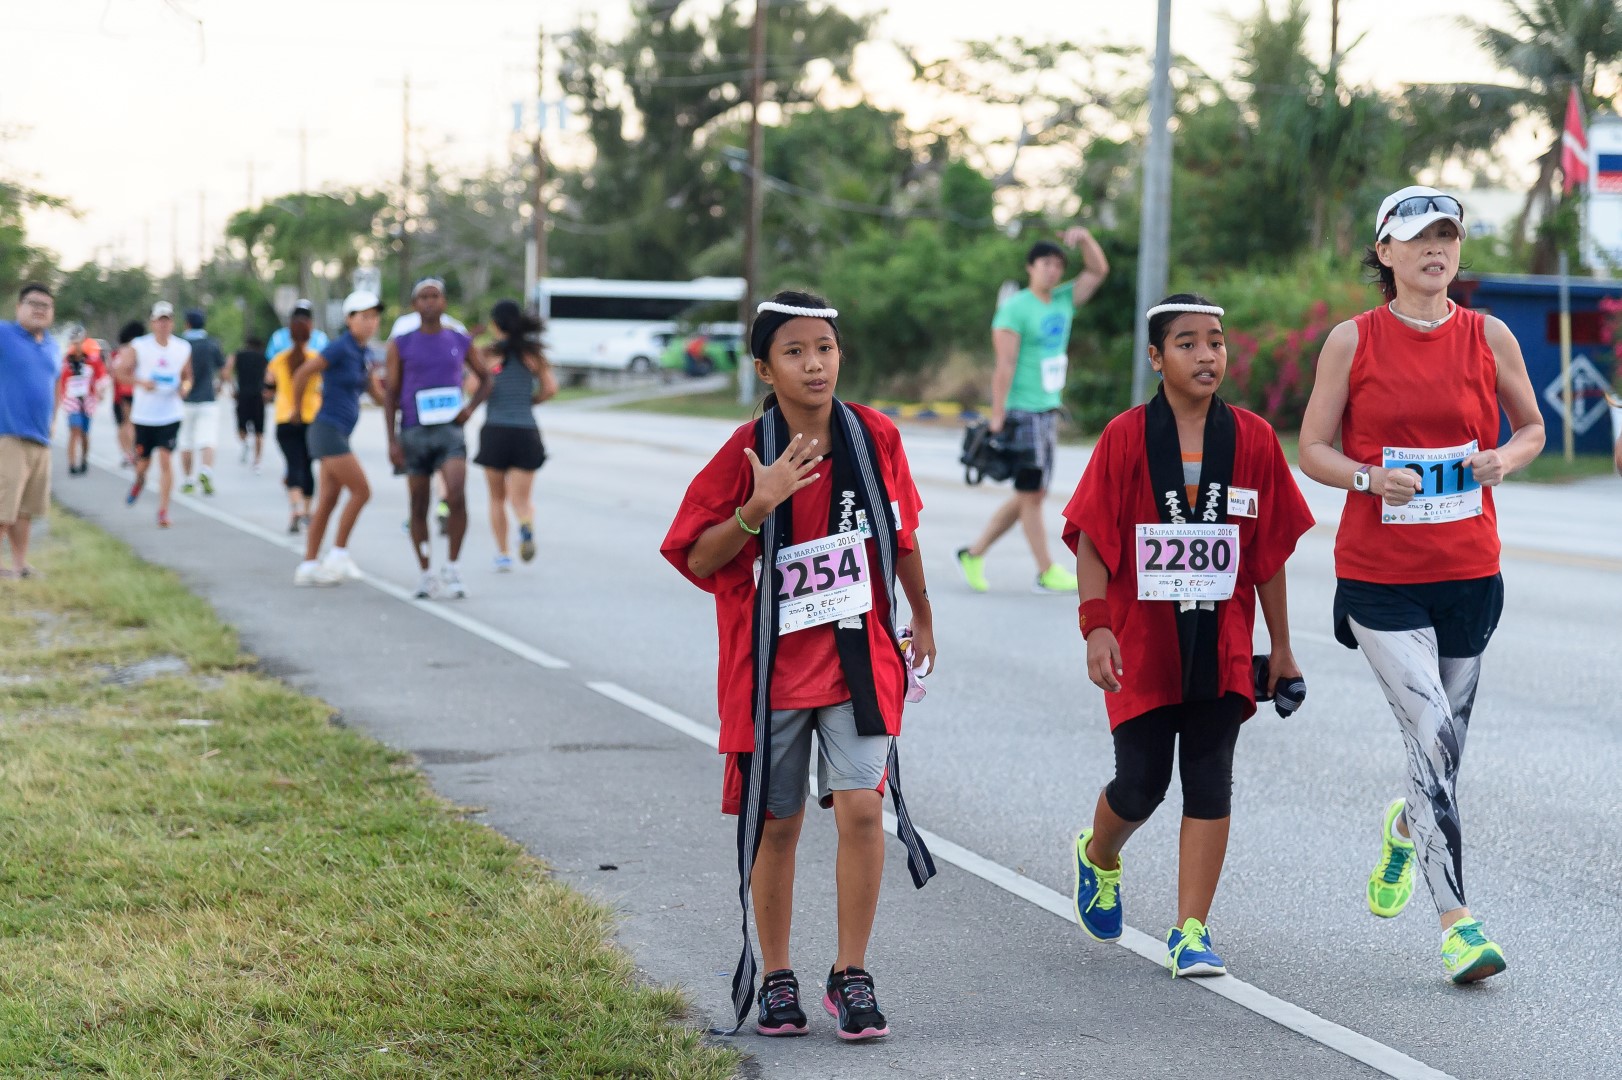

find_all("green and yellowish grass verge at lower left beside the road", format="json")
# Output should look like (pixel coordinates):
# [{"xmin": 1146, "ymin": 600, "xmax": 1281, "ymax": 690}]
[{"xmin": 0, "ymin": 512, "xmax": 738, "ymax": 1078}]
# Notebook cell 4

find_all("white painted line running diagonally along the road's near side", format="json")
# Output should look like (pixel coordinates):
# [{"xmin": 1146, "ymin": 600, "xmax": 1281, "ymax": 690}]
[{"xmin": 79, "ymin": 459, "xmax": 1457, "ymax": 1080}]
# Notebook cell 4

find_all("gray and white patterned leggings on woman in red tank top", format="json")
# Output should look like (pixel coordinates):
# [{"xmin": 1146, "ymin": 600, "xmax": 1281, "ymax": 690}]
[{"xmin": 1348, "ymin": 619, "xmax": 1481, "ymax": 915}]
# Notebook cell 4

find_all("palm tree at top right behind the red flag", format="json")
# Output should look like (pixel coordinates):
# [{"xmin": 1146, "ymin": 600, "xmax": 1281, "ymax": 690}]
[{"xmin": 1460, "ymin": 0, "xmax": 1622, "ymax": 262}]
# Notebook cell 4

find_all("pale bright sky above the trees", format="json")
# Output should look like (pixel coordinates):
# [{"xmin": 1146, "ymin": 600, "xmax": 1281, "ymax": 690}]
[{"xmin": 0, "ymin": 0, "xmax": 1502, "ymax": 272}]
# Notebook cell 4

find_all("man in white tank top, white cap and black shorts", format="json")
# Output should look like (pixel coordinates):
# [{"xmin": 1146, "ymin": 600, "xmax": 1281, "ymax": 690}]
[{"xmin": 114, "ymin": 300, "xmax": 191, "ymax": 529}]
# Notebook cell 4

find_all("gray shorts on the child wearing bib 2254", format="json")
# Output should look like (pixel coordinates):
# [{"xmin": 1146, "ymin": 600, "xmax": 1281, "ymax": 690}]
[{"xmin": 766, "ymin": 701, "xmax": 890, "ymax": 819}]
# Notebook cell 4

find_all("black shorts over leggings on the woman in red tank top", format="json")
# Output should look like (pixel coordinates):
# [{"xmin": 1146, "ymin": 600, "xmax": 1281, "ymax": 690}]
[{"xmin": 1335, "ymin": 574, "xmax": 1504, "ymax": 658}]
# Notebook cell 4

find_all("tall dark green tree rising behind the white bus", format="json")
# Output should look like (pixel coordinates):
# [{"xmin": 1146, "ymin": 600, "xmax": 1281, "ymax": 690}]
[{"xmin": 548, "ymin": 0, "xmax": 871, "ymax": 279}]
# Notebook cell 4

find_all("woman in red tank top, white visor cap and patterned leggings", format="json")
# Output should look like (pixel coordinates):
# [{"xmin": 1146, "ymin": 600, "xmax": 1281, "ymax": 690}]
[{"xmin": 1301, "ymin": 186, "xmax": 1544, "ymax": 983}]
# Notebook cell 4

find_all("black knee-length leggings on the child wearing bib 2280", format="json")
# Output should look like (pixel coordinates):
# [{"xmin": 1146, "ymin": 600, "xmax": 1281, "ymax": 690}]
[{"xmin": 1105, "ymin": 694, "xmax": 1244, "ymax": 822}]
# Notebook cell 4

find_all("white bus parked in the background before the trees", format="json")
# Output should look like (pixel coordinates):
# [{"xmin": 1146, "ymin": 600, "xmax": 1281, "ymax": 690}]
[{"xmin": 539, "ymin": 277, "xmax": 744, "ymax": 371}]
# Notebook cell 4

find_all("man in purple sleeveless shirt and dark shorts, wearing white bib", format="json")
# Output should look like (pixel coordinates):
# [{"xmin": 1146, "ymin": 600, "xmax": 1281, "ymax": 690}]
[{"xmin": 383, "ymin": 277, "xmax": 490, "ymax": 600}]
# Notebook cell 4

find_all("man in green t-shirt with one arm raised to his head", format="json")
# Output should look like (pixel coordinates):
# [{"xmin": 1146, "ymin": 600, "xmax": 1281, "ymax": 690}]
[{"xmin": 957, "ymin": 225, "xmax": 1109, "ymax": 595}]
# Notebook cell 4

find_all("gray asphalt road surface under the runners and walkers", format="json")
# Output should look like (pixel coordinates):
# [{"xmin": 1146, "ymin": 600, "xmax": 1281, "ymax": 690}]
[{"xmin": 55, "ymin": 395, "xmax": 1622, "ymax": 1078}]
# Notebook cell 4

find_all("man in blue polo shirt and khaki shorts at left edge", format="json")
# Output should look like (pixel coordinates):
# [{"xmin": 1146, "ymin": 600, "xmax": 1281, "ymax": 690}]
[{"xmin": 0, "ymin": 284, "xmax": 57, "ymax": 577}]
